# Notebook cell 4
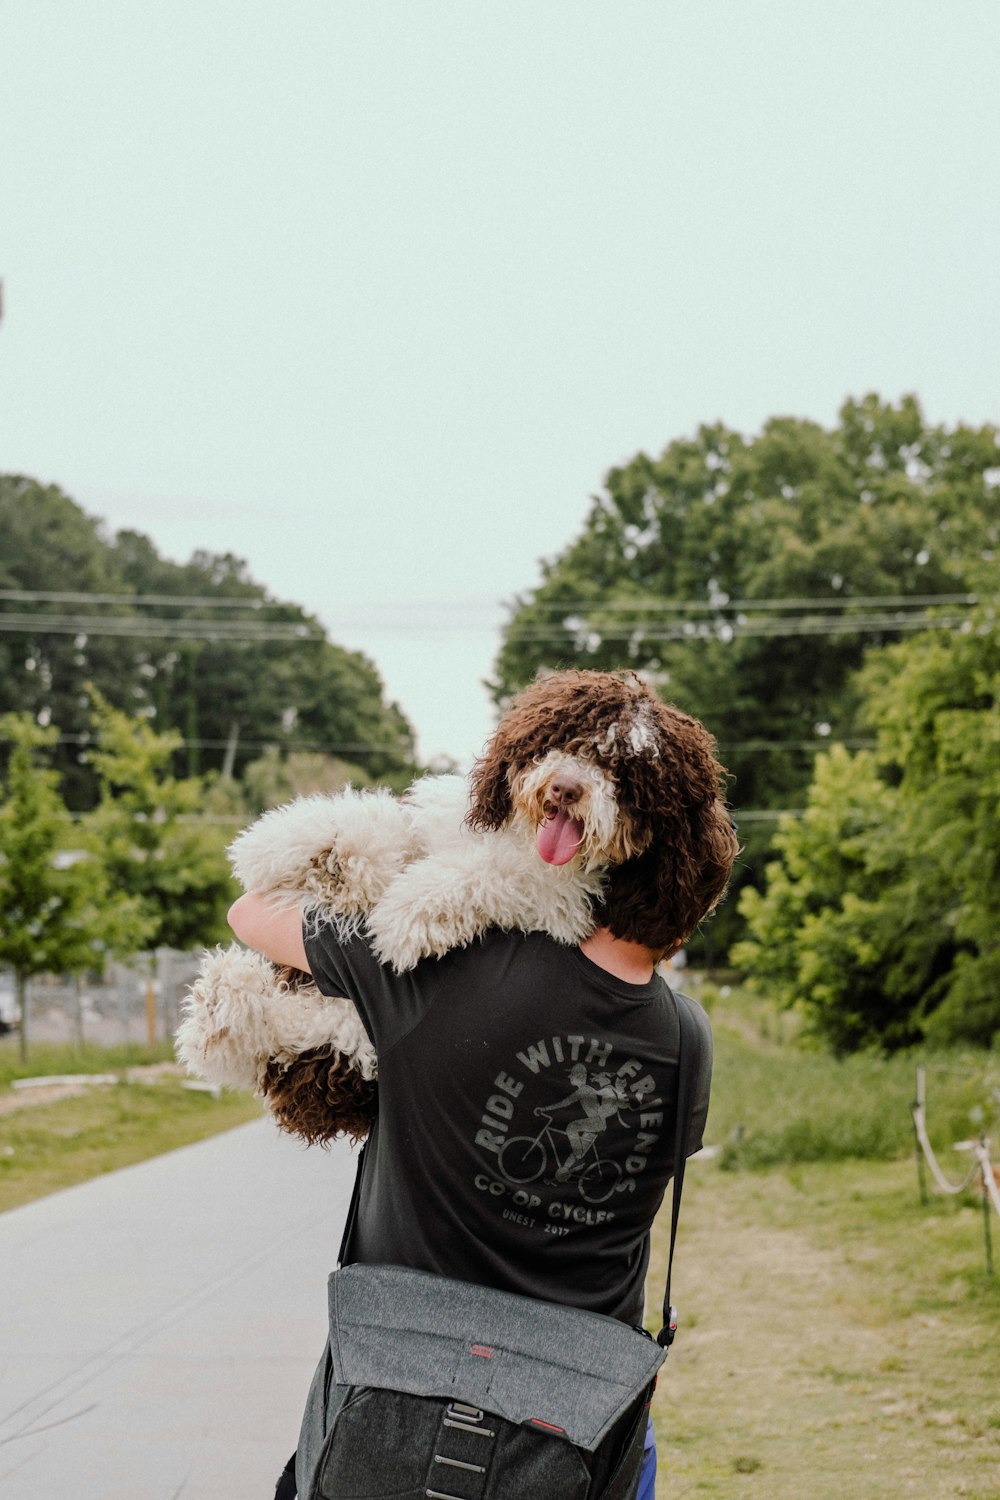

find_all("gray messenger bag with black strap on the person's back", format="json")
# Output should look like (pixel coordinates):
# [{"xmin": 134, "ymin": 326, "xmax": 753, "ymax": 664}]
[{"xmin": 279, "ymin": 984, "xmax": 700, "ymax": 1500}]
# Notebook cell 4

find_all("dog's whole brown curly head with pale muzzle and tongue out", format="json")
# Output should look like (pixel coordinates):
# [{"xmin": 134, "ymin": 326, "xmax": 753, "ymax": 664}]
[{"xmin": 468, "ymin": 672, "xmax": 739, "ymax": 948}]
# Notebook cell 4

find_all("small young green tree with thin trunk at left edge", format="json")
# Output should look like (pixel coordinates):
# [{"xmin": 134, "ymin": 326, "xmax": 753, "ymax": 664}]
[{"xmin": 0, "ymin": 714, "xmax": 144, "ymax": 1058}]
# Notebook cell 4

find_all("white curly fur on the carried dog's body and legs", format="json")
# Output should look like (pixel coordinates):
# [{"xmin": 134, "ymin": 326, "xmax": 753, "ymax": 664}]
[{"xmin": 177, "ymin": 768, "xmax": 605, "ymax": 1091}]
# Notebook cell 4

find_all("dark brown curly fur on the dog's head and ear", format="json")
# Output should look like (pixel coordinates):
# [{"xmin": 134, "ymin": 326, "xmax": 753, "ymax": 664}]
[{"xmin": 468, "ymin": 672, "xmax": 739, "ymax": 950}]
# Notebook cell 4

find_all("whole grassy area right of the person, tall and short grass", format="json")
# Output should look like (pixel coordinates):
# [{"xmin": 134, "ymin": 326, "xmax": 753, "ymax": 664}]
[{"xmin": 649, "ymin": 1004, "xmax": 1000, "ymax": 1500}]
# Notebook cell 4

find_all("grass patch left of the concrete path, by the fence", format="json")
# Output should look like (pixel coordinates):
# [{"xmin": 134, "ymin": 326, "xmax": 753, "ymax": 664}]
[{"xmin": 0, "ymin": 1038, "xmax": 261, "ymax": 1212}]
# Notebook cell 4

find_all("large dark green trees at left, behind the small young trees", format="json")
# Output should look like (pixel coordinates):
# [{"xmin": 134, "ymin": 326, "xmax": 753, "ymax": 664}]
[{"xmin": 0, "ymin": 476, "xmax": 414, "ymax": 810}]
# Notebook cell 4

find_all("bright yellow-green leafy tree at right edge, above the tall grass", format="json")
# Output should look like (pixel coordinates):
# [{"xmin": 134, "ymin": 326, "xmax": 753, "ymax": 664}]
[{"xmin": 732, "ymin": 608, "xmax": 1000, "ymax": 1052}]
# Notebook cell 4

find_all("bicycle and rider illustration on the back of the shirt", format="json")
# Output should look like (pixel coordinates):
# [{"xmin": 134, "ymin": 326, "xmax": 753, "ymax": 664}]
[{"xmin": 498, "ymin": 1062, "xmax": 628, "ymax": 1203}]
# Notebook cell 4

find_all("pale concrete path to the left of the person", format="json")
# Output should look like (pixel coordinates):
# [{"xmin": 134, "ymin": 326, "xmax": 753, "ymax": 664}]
[{"xmin": 0, "ymin": 1121, "xmax": 355, "ymax": 1500}]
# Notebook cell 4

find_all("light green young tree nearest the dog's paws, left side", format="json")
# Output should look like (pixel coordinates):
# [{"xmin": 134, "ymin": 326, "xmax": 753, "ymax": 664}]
[{"xmin": 88, "ymin": 693, "xmax": 234, "ymax": 950}]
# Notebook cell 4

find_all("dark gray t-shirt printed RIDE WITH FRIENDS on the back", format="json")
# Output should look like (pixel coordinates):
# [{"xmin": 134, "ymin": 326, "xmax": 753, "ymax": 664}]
[{"xmin": 306, "ymin": 927, "xmax": 712, "ymax": 1323}]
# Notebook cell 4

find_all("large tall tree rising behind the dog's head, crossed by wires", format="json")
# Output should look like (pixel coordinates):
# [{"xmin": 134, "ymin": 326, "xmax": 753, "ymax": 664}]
[{"xmin": 493, "ymin": 396, "xmax": 1000, "ymax": 948}]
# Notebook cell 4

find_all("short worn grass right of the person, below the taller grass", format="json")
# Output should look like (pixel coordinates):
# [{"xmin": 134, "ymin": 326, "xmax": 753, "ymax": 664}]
[{"xmin": 651, "ymin": 1161, "xmax": 1000, "ymax": 1500}]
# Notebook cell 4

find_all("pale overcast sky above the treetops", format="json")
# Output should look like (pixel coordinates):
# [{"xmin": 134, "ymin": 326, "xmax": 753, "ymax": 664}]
[{"xmin": 0, "ymin": 0, "xmax": 1000, "ymax": 762}]
